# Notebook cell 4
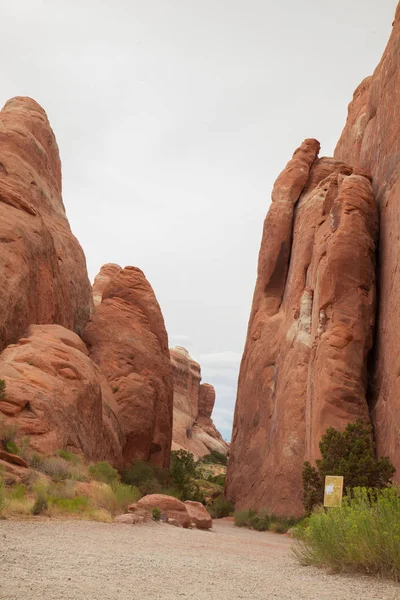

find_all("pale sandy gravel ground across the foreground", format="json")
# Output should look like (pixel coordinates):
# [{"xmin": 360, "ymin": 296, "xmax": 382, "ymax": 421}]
[{"xmin": 0, "ymin": 521, "xmax": 400, "ymax": 600}]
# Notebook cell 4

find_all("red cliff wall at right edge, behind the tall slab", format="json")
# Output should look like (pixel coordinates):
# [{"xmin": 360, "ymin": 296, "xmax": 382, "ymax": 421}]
[{"xmin": 335, "ymin": 5, "xmax": 400, "ymax": 482}]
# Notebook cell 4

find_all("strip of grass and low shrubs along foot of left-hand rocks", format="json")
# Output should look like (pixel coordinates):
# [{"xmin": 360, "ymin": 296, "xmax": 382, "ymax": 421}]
[{"xmin": 0, "ymin": 408, "xmax": 228, "ymax": 521}]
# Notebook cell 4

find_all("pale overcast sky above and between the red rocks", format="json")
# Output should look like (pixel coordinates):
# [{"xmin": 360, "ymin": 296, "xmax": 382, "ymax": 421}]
[{"xmin": 0, "ymin": 0, "xmax": 397, "ymax": 438}]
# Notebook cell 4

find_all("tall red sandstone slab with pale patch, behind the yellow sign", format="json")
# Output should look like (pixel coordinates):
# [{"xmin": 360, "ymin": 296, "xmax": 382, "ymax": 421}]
[{"xmin": 227, "ymin": 140, "xmax": 378, "ymax": 515}]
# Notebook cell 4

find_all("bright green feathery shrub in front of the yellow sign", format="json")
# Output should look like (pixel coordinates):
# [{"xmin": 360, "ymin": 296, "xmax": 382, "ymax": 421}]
[{"xmin": 294, "ymin": 488, "xmax": 400, "ymax": 581}]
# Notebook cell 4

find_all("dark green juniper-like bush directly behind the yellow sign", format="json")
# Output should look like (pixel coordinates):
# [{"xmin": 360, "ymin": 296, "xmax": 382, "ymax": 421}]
[{"xmin": 302, "ymin": 419, "xmax": 395, "ymax": 514}]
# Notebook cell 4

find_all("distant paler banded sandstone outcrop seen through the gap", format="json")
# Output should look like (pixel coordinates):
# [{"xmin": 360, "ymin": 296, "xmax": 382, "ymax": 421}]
[{"xmin": 170, "ymin": 346, "xmax": 228, "ymax": 458}]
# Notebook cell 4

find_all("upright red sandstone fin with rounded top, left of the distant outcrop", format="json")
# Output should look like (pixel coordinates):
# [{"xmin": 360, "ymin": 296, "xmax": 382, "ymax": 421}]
[{"xmin": 83, "ymin": 265, "xmax": 173, "ymax": 467}]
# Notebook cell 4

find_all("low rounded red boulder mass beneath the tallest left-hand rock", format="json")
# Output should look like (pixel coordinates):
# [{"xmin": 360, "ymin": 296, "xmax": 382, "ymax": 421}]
[{"xmin": 0, "ymin": 325, "xmax": 122, "ymax": 467}]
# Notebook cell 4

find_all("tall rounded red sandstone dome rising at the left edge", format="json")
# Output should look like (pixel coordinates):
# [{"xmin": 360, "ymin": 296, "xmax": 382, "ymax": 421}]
[{"xmin": 0, "ymin": 98, "xmax": 92, "ymax": 350}]
